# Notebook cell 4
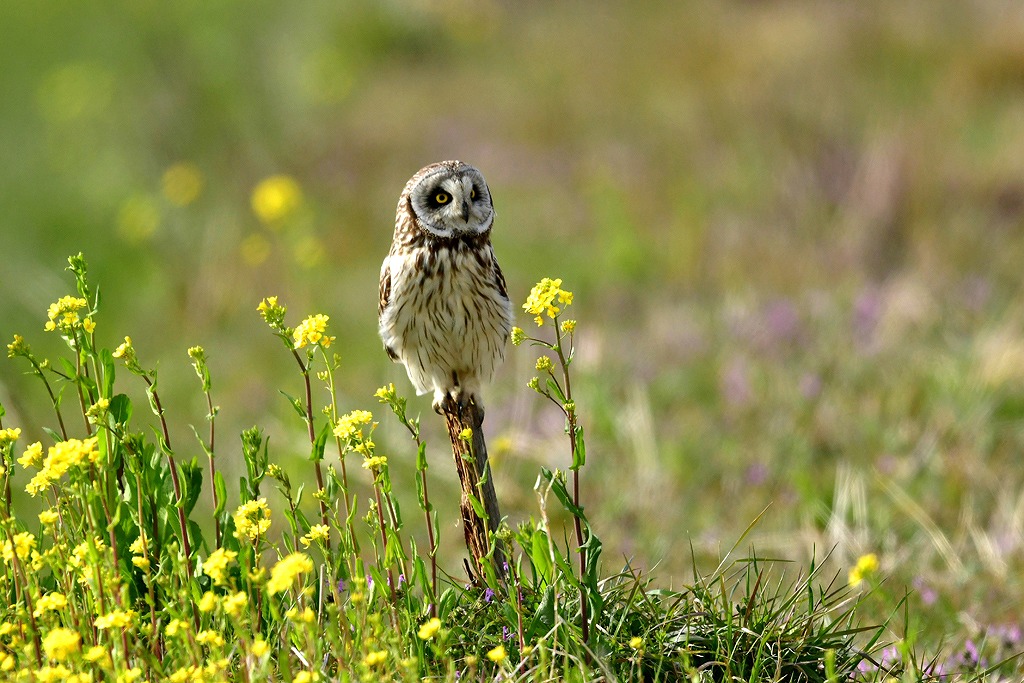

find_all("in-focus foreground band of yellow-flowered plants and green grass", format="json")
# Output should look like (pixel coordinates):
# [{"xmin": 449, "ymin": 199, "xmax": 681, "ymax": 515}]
[{"xmin": 0, "ymin": 255, "xmax": 1017, "ymax": 682}]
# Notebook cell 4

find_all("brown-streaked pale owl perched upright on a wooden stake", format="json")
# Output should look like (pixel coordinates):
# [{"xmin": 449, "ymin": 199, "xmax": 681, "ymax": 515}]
[{"xmin": 378, "ymin": 161, "xmax": 512, "ymax": 413}]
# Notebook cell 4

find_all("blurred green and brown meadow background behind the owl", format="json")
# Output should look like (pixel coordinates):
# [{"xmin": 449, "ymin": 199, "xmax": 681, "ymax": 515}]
[{"xmin": 0, "ymin": 0, "xmax": 1024, "ymax": 663}]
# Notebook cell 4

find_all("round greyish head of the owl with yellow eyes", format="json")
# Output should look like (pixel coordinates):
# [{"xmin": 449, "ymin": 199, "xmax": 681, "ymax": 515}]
[{"xmin": 399, "ymin": 161, "xmax": 495, "ymax": 239}]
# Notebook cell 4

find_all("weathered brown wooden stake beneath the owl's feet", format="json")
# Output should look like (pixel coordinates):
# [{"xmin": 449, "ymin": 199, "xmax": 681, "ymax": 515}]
[{"xmin": 440, "ymin": 399, "xmax": 505, "ymax": 581}]
